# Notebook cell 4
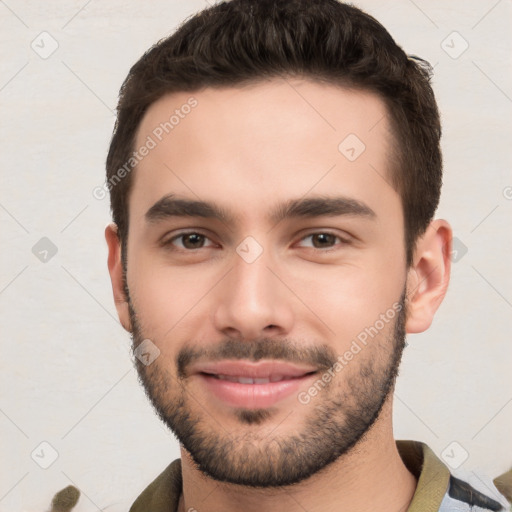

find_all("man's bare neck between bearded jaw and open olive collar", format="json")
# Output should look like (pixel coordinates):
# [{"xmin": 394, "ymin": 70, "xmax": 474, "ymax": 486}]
[{"xmin": 178, "ymin": 400, "xmax": 417, "ymax": 512}]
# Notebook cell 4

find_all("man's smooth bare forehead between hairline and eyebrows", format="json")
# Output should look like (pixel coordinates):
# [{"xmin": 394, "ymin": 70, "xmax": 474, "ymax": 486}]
[{"xmin": 130, "ymin": 78, "xmax": 396, "ymax": 224}]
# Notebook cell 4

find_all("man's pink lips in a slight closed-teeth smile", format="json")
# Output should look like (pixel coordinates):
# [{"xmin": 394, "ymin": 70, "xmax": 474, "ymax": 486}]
[{"xmin": 192, "ymin": 361, "xmax": 318, "ymax": 409}]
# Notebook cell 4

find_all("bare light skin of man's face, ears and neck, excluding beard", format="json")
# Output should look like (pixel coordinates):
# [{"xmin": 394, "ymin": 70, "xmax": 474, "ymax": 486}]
[{"xmin": 105, "ymin": 79, "xmax": 452, "ymax": 512}]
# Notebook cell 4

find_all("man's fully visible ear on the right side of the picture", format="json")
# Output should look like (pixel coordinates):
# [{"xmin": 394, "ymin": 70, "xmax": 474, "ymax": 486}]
[{"xmin": 405, "ymin": 219, "xmax": 452, "ymax": 333}]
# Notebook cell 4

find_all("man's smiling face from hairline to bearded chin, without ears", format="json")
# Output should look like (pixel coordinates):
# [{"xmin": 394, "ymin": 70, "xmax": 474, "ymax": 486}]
[{"xmin": 122, "ymin": 79, "xmax": 406, "ymax": 487}]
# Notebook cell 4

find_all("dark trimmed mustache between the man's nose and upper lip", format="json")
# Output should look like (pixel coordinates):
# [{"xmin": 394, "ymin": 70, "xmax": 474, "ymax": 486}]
[{"xmin": 176, "ymin": 338, "xmax": 337, "ymax": 379}]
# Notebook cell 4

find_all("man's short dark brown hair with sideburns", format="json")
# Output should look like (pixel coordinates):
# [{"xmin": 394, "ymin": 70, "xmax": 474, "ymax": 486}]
[{"xmin": 107, "ymin": 0, "xmax": 442, "ymax": 264}]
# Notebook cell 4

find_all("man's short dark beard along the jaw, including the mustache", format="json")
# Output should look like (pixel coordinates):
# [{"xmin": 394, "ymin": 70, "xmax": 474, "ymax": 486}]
[{"xmin": 127, "ymin": 292, "xmax": 406, "ymax": 488}]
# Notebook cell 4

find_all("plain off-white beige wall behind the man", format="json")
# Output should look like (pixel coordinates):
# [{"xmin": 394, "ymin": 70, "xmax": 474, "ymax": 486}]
[{"xmin": 0, "ymin": 0, "xmax": 512, "ymax": 512}]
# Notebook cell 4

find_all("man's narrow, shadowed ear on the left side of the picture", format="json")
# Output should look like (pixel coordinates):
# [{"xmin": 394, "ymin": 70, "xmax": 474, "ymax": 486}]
[{"xmin": 105, "ymin": 223, "xmax": 132, "ymax": 332}]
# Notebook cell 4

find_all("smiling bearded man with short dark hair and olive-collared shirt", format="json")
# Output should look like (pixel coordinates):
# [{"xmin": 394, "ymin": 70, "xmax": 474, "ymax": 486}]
[{"xmin": 98, "ymin": 0, "xmax": 506, "ymax": 512}]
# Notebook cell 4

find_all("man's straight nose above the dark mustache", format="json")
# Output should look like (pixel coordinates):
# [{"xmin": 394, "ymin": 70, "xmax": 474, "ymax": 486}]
[{"xmin": 214, "ymin": 247, "xmax": 294, "ymax": 340}]
